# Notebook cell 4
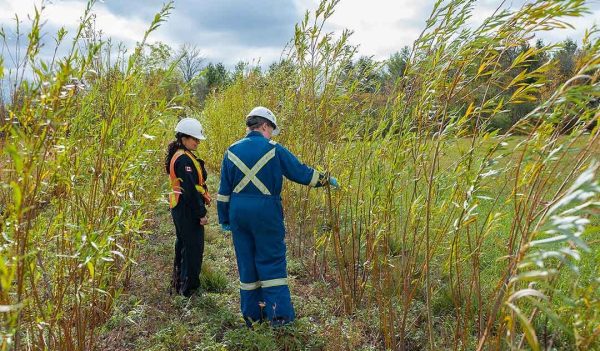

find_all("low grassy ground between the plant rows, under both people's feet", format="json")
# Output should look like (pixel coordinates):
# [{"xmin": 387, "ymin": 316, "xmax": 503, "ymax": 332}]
[{"xmin": 97, "ymin": 199, "xmax": 378, "ymax": 350}]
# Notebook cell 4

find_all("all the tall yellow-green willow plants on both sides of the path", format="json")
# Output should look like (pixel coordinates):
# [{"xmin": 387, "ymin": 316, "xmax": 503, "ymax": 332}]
[{"xmin": 0, "ymin": 0, "xmax": 600, "ymax": 350}]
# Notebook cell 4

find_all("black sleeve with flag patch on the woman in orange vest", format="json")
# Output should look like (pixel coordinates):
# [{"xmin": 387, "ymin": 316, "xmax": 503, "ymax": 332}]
[{"xmin": 175, "ymin": 155, "xmax": 207, "ymax": 219}]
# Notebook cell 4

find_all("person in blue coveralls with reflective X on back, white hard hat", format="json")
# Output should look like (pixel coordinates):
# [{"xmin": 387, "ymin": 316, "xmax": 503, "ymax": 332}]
[{"xmin": 217, "ymin": 106, "xmax": 339, "ymax": 326}]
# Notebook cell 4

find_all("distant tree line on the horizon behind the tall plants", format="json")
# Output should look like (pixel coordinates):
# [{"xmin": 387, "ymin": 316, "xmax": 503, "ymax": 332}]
[{"xmin": 144, "ymin": 39, "xmax": 598, "ymax": 132}]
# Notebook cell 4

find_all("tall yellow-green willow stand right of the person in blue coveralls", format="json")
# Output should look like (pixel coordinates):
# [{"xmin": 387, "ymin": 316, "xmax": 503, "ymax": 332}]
[{"xmin": 204, "ymin": 0, "xmax": 600, "ymax": 350}]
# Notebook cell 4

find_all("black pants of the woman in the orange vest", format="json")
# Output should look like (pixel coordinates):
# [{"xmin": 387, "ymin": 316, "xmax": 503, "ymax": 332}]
[{"xmin": 171, "ymin": 208, "xmax": 204, "ymax": 296}]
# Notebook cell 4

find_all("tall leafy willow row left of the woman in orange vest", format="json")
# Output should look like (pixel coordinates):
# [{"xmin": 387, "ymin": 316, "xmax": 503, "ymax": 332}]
[{"xmin": 0, "ymin": 1, "xmax": 185, "ymax": 350}]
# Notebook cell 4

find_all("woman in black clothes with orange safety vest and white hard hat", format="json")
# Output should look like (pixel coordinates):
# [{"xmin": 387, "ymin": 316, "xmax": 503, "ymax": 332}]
[{"xmin": 165, "ymin": 117, "xmax": 211, "ymax": 297}]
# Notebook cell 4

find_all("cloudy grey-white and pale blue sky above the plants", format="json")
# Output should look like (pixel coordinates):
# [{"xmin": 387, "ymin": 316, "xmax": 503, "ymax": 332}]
[{"xmin": 0, "ymin": 0, "xmax": 600, "ymax": 67}]
